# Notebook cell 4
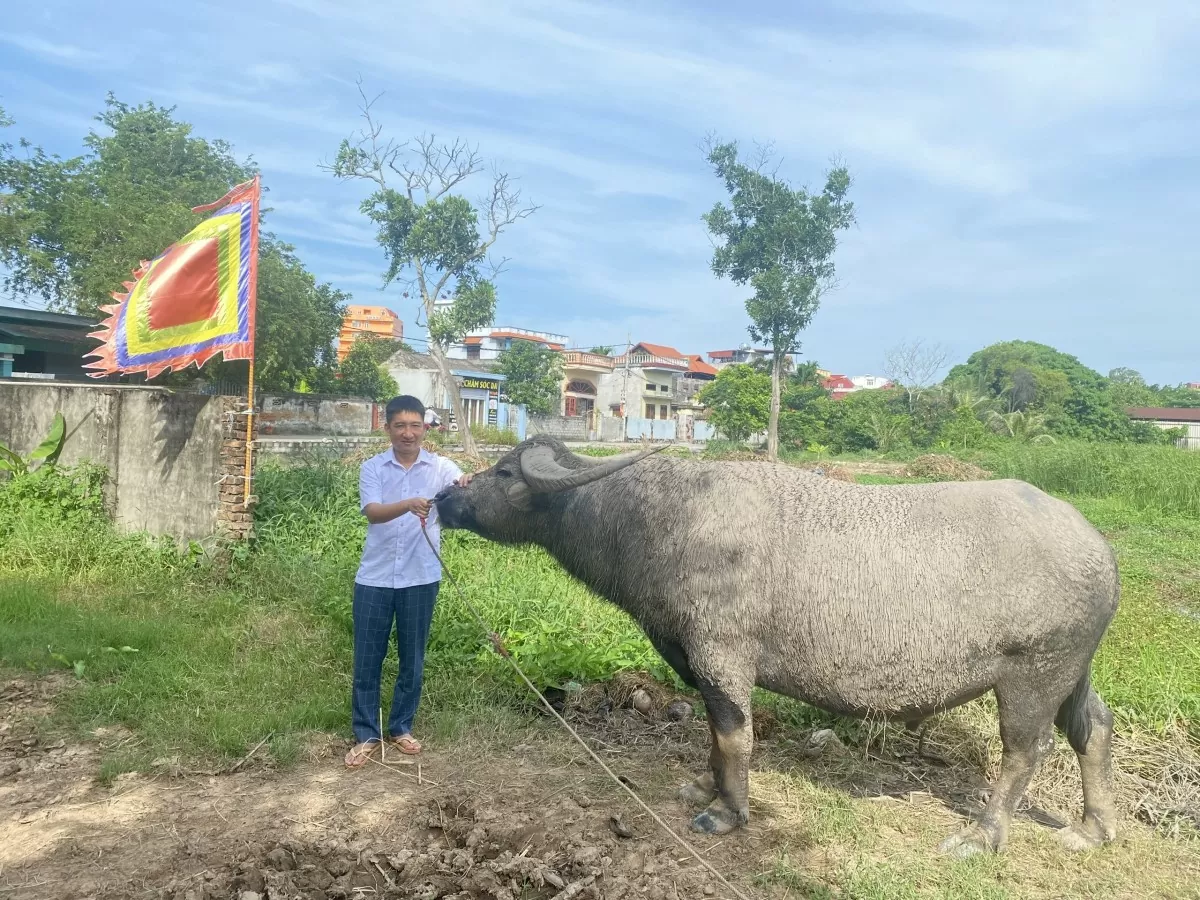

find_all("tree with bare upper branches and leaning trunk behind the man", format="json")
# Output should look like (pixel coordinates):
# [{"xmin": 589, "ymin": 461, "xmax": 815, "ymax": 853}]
[{"xmin": 325, "ymin": 85, "xmax": 536, "ymax": 455}]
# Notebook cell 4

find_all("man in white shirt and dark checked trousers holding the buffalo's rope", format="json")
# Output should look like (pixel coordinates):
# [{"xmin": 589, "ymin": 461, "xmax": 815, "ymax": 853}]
[{"xmin": 346, "ymin": 395, "xmax": 470, "ymax": 768}]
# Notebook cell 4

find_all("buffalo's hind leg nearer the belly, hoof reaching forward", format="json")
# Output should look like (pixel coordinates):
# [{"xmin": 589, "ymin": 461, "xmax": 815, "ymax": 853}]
[{"xmin": 938, "ymin": 680, "xmax": 1061, "ymax": 857}]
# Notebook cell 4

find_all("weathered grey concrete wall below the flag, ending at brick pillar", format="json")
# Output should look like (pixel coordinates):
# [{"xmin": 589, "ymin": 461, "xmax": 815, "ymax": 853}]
[{"xmin": 0, "ymin": 382, "xmax": 250, "ymax": 540}]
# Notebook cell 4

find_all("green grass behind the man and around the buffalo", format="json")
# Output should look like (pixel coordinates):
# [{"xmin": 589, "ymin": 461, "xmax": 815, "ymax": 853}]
[{"xmin": 0, "ymin": 448, "xmax": 1200, "ymax": 764}]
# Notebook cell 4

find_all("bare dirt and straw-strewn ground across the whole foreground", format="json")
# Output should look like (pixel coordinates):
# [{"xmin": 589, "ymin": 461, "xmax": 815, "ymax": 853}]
[{"xmin": 0, "ymin": 678, "xmax": 1200, "ymax": 900}]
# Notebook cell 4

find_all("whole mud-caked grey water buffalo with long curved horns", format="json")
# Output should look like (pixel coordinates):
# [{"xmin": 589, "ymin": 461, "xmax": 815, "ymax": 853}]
[{"xmin": 436, "ymin": 436, "xmax": 1120, "ymax": 856}]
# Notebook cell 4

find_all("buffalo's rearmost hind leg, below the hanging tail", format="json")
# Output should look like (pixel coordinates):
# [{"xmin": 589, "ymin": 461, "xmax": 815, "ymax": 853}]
[{"xmin": 1055, "ymin": 678, "xmax": 1117, "ymax": 851}]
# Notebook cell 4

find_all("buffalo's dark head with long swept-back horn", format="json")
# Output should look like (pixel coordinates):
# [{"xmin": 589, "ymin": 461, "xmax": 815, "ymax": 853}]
[{"xmin": 433, "ymin": 434, "xmax": 665, "ymax": 544}]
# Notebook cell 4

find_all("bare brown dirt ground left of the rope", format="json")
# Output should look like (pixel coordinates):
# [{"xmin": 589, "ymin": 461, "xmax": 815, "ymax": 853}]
[{"xmin": 0, "ymin": 679, "xmax": 772, "ymax": 900}]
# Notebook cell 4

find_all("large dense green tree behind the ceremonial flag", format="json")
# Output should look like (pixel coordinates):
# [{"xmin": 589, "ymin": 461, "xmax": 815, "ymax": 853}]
[{"xmin": 0, "ymin": 95, "xmax": 349, "ymax": 390}]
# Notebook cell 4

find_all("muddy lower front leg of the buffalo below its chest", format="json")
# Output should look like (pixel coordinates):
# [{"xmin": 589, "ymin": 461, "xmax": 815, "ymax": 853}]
[{"xmin": 684, "ymin": 680, "xmax": 754, "ymax": 834}]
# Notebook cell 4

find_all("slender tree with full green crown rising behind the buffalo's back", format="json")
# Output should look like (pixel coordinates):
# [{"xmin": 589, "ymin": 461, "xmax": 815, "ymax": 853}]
[{"xmin": 704, "ymin": 142, "xmax": 854, "ymax": 458}]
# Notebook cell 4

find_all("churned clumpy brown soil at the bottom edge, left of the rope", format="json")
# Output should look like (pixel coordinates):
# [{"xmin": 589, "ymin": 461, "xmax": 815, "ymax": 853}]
[{"xmin": 157, "ymin": 791, "xmax": 716, "ymax": 900}]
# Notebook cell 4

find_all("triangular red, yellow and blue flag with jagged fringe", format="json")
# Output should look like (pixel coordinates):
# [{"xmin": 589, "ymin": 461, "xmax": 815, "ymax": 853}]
[{"xmin": 85, "ymin": 175, "xmax": 260, "ymax": 378}]
